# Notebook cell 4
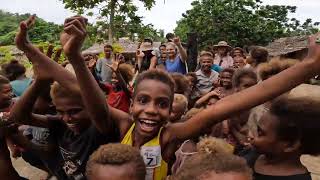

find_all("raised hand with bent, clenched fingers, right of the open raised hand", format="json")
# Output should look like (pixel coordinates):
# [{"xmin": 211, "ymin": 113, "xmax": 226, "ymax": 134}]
[{"xmin": 60, "ymin": 16, "xmax": 87, "ymax": 57}]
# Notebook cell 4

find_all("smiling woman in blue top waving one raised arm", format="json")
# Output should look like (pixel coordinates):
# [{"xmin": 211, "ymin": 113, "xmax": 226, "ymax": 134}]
[{"xmin": 165, "ymin": 37, "xmax": 188, "ymax": 74}]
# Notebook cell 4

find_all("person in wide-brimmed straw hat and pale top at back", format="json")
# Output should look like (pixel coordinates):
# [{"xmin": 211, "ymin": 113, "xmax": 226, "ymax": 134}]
[{"xmin": 213, "ymin": 41, "xmax": 233, "ymax": 68}]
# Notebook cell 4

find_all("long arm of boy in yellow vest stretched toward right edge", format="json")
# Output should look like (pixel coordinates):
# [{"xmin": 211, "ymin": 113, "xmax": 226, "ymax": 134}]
[{"xmin": 166, "ymin": 34, "xmax": 320, "ymax": 141}]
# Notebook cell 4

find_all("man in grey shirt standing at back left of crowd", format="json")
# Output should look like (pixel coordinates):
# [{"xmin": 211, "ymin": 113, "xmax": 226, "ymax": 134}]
[{"xmin": 96, "ymin": 44, "xmax": 113, "ymax": 83}]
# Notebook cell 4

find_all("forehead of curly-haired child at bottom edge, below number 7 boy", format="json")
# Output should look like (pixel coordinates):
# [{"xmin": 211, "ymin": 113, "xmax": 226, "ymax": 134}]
[{"xmin": 88, "ymin": 165, "xmax": 138, "ymax": 180}]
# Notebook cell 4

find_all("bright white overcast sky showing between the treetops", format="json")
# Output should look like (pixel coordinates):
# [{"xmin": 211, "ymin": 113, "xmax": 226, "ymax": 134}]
[{"xmin": 0, "ymin": 0, "xmax": 320, "ymax": 33}]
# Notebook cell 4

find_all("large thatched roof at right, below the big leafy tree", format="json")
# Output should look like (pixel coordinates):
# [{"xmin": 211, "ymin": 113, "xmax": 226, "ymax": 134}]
[{"xmin": 266, "ymin": 36, "xmax": 308, "ymax": 57}]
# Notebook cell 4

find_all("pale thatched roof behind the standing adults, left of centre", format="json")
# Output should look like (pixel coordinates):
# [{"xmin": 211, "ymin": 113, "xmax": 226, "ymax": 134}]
[{"xmin": 82, "ymin": 39, "xmax": 161, "ymax": 54}]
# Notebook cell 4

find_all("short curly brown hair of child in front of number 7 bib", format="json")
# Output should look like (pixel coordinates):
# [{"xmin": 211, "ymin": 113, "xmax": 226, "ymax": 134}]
[{"xmin": 86, "ymin": 143, "xmax": 146, "ymax": 180}]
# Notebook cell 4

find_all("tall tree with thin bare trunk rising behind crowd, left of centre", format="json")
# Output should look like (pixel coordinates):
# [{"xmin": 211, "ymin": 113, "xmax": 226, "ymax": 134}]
[{"xmin": 62, "ymin": 0, "xmax": 155, "ymax": 43}]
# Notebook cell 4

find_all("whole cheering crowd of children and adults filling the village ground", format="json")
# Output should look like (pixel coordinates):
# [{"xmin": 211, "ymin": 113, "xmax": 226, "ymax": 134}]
[{"xmin": 0, "ymin": 16, "xmax": 320, "ymax": 180}]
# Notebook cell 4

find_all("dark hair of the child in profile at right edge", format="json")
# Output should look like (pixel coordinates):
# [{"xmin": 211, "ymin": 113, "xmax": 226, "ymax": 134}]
[{"xmin": 270, "ymin": 92, "xmax": 320, "ymax": 155}]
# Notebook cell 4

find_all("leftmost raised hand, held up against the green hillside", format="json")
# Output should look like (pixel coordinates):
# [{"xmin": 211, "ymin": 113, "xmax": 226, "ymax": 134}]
[{"xmin": 15, "ymin": 15, "xmax": 36, "ymax": 52}]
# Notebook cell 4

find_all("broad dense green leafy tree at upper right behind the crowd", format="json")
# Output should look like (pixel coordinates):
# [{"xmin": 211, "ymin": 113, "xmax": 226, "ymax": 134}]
[{"xmin": 175, "ymin": 0, "xmax": 319, "ymax": 47}]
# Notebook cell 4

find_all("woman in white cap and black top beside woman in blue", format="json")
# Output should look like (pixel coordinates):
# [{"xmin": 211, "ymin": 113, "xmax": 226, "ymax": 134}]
[{"xmin": 136, "ymin": 38, "xmax": 157, "ymax": 73}]
